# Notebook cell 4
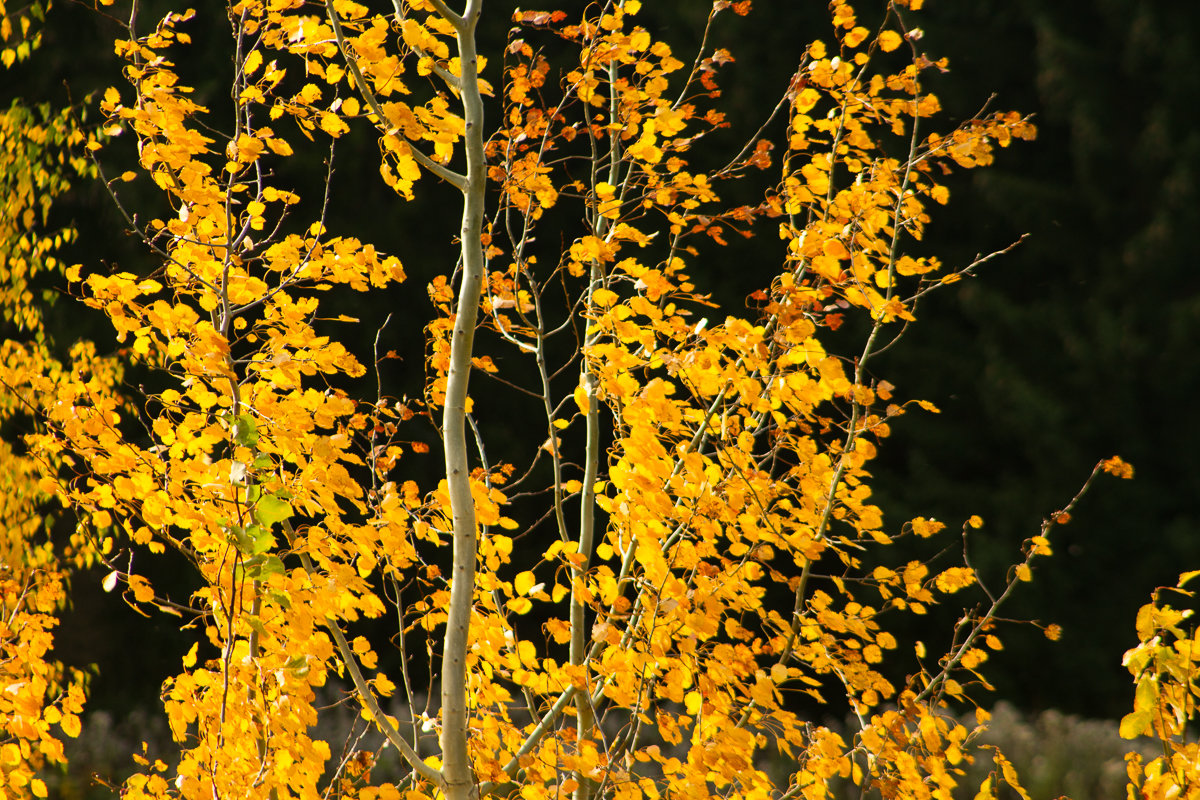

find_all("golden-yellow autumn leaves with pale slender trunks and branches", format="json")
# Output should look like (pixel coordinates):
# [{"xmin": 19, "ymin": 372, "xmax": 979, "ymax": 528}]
[{"xmin": 0, "ymin": 0, "xmax": 1180, "ymax": 800}]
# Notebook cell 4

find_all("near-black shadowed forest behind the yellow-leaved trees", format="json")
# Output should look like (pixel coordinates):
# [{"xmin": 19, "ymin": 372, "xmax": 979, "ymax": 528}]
[{"xmin": 9, "ymin": 0, "xmax": 1200, "ymax": 738}]
